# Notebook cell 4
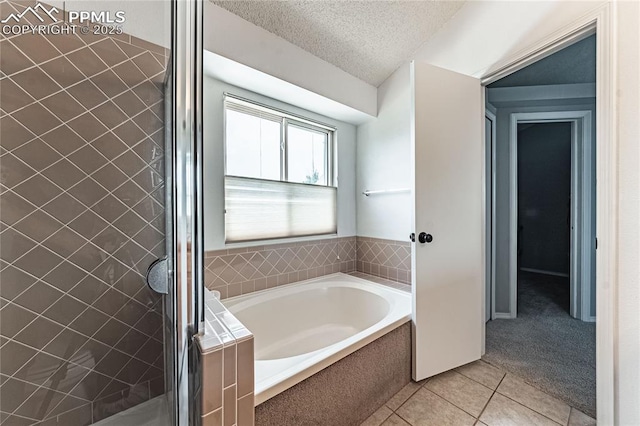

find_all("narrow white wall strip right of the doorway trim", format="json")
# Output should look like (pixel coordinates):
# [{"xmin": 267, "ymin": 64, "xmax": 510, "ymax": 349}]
[{"xmin": 614, "ymin": 1, "xmax": 640, "ymax": 425}]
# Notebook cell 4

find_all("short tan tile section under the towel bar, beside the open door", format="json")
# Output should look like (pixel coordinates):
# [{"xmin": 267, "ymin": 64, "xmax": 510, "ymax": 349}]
[{"xmin": 356, "ymin": 237, "xmax": 411, "ymax": 284}]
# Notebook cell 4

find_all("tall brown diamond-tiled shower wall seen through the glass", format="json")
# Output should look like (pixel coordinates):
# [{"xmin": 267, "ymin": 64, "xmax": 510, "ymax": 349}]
[{"xmin": 0, "ymin": 2, "xmax": 167, "ymax": 426}]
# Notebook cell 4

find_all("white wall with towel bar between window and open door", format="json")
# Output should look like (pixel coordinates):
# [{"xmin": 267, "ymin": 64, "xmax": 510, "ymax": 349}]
[{"xmin": 356, "ymin": 64, "xmax": 412, "ymax": 241}]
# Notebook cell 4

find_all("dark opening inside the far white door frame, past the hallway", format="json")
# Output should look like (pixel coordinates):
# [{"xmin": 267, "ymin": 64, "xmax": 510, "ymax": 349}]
[{"xmin": 516, "ymin": 122, "xmax": 575, "ymax": 315}]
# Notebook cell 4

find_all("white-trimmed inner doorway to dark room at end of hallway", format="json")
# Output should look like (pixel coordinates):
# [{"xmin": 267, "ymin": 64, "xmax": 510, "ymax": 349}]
[{"xmin": 509, "ymin": 110, "xmax": 595, "ymax": 322}]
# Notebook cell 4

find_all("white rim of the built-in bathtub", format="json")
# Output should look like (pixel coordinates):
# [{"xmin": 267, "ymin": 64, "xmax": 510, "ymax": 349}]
[{"xmin": 222, "ymin": 272, "xmax": 412, "ymax": 406}]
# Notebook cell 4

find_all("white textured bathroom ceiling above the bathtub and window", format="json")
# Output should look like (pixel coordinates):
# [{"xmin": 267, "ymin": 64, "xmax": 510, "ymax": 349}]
[{"xmin": 211, "ymin": 0, "xmax": 464, "ymax": 87}]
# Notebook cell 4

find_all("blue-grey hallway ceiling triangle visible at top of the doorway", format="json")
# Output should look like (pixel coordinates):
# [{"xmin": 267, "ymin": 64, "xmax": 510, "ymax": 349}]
[{"xmin": 489, "ymin": 35, "xmax": 596, "ymax": 88}]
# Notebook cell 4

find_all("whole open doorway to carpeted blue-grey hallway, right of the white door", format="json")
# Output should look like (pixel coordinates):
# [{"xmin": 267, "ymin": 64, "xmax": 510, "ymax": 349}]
[{"xmin": 483, "ymin": 35, "xmax": 596, "ymax": 417}]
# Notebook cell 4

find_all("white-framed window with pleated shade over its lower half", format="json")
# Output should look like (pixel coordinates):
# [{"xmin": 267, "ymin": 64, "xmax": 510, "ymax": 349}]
[{"xmin": 224, "ymin": 95, "xmax": 337, "ymax": 242}]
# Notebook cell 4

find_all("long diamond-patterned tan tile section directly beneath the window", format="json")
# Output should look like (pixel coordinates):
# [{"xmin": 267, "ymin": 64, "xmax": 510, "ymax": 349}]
[{"xmin": 205, "ymin": 237, "xmax": 356, "ymax": 298}]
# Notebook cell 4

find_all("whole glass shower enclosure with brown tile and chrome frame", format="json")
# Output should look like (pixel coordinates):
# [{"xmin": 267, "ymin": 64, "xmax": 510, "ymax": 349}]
[{"xmin": 0, "ymin": 0, "xmax": 198, "ymax": 426}]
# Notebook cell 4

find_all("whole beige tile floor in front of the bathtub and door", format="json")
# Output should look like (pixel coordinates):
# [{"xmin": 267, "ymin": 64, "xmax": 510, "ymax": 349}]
[{"xmin": 361, "ymin": 361, "xmax": 596, "ymax": 426}]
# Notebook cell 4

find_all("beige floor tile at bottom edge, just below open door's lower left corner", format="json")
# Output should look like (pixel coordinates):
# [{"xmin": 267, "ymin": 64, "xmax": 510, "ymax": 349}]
[{"xmin": 396, "ymin": 388, "xmax": 476, "ymax": 426}]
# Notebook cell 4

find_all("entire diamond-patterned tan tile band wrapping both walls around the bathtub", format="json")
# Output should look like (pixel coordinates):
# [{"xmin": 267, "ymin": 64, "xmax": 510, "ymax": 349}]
[{"xmin": 205, "ymin": 237, "xmax": 411, "ymax": 299}]
